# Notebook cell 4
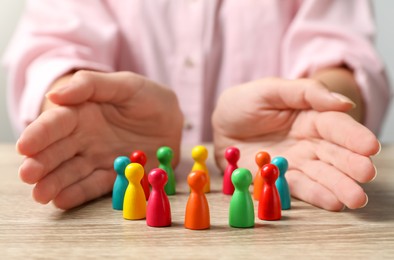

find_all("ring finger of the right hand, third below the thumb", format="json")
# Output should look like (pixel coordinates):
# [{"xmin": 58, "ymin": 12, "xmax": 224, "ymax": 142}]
[{"xmin": 301, "ymin": 160, "xmax": 368, "ymax": 209}]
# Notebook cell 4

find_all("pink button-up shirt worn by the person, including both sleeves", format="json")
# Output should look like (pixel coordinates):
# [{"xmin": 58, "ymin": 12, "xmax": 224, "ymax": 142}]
[{"xmin": 5, "ymin": 0, "xmax": 390, "ymax": 142}]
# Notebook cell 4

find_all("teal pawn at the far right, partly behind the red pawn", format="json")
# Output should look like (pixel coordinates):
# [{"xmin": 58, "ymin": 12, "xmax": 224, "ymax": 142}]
[{"xmin": 271, "ymin": 156, "xmax": 291, "ymax": 210}]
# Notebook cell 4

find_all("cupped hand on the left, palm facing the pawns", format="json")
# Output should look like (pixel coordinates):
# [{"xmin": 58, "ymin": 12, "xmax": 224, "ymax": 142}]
[{"xmin": 17, "ymin": 71, "xmax": 183, "ymax": 209}]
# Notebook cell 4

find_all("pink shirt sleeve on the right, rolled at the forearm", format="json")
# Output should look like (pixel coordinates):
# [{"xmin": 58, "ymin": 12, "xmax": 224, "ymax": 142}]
[{"xmin": 281, "ymin": 0, "xmax": 390, "ymax": 134}]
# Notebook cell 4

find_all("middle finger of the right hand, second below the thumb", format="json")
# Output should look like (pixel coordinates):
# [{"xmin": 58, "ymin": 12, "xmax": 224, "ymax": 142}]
[{"xmin": 314, "ymin": 141, "xmax": 377, "ymax": 183}]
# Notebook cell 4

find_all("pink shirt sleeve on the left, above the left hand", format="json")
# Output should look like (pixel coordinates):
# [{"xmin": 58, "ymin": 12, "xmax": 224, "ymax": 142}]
[{"xmin": 3, "ymin": 0, "xmax": 119, "ymax": 132}]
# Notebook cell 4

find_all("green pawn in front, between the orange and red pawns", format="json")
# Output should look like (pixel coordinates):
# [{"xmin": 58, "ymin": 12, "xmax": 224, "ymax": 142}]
[{"xmin": 229, "ymin": 168, "xmax": 254, "ymax": 228}]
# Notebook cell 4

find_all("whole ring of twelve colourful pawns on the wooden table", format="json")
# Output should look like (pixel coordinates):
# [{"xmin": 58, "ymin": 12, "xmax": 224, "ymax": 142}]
[{"xmin": 112, "ymin": 145, "xmax": 290, "ymax": 230}]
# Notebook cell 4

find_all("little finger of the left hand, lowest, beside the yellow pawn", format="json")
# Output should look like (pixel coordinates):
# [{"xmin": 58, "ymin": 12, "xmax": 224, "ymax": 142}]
[{"xmin": 53, "ymin": 170, "xmax": 116, "ymax": 210}]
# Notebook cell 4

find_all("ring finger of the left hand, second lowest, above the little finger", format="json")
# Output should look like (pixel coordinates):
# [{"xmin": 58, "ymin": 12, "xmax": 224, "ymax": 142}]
[{"xmin": 33, "ymin": 156, "xmax": 93, "ymax": 204}]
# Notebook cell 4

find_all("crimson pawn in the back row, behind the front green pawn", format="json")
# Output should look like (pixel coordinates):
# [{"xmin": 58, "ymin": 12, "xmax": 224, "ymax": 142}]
[{"xmin": 223, "ymin": 147, "xmax": 240, "ymax": 195}]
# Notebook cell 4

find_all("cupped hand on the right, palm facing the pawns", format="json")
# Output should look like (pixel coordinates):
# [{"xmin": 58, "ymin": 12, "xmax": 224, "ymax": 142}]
[{"xmin": 212, "ymin": 78, "xmax": 380, "ymax": 211}]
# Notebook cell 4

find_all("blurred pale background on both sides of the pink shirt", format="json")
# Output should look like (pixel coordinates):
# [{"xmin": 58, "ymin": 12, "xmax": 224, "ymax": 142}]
[{"xmin": 0, "ymin": 0, "xmax": 394, "ymax": 142}]
